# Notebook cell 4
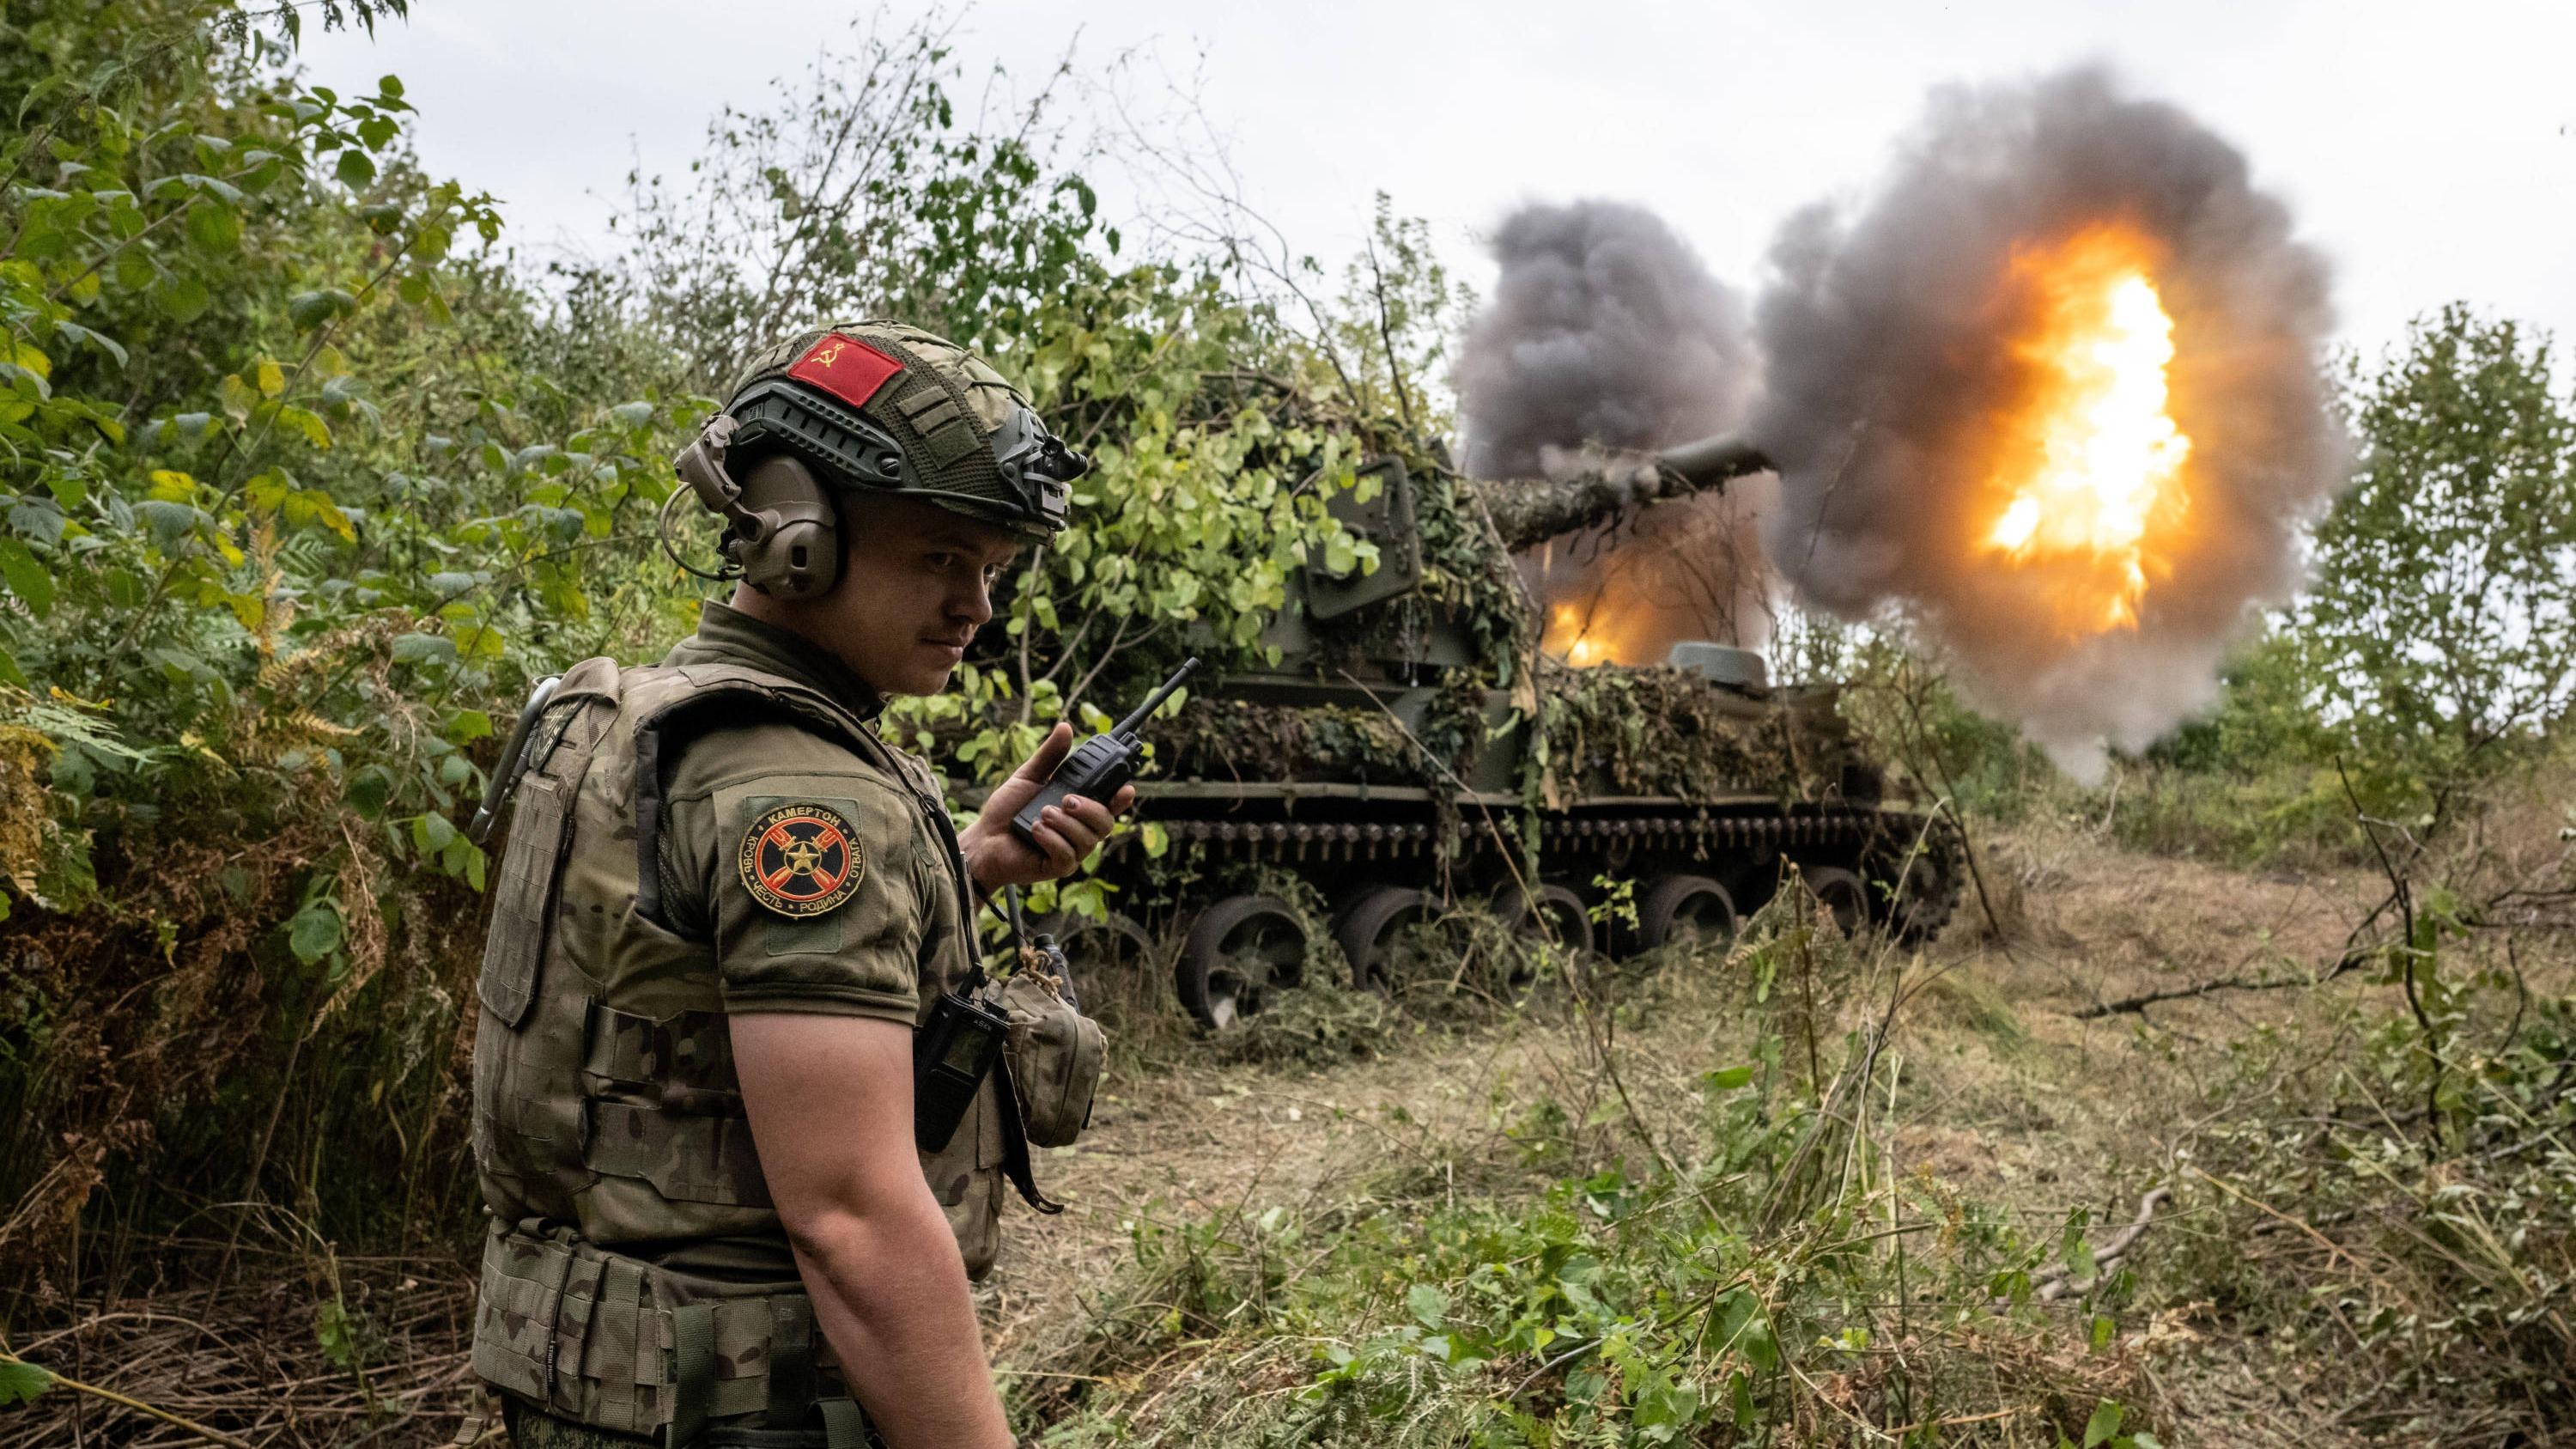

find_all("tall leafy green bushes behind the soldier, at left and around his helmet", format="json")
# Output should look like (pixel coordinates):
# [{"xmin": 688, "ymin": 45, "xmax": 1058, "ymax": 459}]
[{"xmin": 0, "ymin": 0, "xmax": 1427, "ymax": 1289}]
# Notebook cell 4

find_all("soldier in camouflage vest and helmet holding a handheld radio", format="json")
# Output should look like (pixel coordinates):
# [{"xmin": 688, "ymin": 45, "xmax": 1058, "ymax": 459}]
[{"xmin": 474, "ymin": 322, "xmax": 1133, "ymax": 1449}]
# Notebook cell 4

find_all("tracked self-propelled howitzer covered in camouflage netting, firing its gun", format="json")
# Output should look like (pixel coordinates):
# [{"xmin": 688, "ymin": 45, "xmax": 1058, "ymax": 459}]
[{"xmin": 1036, "ymin": 438, "xmax": 1960, "ymax": 1029}]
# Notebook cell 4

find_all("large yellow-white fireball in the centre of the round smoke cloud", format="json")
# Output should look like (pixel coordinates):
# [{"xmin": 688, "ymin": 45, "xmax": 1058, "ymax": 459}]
[{"xmin": 1981, "ymin": 224, "xmax": 2192, "ymax": 634}]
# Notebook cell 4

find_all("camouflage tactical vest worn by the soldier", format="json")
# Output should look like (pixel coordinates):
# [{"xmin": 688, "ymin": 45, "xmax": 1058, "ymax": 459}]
[{"xmin": 474, "ymin": 660, "xmax": 999, "ymax": 1449}]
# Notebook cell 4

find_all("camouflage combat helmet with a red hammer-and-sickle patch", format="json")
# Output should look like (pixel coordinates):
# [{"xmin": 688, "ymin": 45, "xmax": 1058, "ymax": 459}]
[{"xmin": 724, "ymin": 320, "xmax": 1090, "ymax": 541}]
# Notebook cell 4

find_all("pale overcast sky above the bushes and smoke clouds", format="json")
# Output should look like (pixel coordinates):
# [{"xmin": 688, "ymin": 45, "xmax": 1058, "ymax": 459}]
[{"xmin": 304, "ymin": 0, "xmax": 2576, "ymax": 350}]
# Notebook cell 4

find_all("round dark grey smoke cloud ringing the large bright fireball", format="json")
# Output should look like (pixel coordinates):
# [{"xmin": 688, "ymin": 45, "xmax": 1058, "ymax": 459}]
[{"xmin": 1749, "ymin": 70, "xmax": 2344, "ymax": 769}]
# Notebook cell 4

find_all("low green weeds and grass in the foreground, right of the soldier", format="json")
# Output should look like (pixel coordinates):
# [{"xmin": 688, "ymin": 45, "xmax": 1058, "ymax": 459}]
[{"xmin": 1018, "ymin": 903, "xmax": 2154, "ymax": 1446}]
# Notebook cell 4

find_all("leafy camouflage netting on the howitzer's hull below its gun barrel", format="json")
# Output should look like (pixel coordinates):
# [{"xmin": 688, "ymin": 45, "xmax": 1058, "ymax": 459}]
[{"xmin": 1538, "ymin": 662, "xmax": 1850, "ymax": 800}]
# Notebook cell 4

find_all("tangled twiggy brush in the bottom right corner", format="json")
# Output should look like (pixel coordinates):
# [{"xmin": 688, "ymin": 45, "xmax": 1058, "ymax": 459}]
[{"xmin": 2159, "ymin": 979, "xmax": 2576, "ymax": 1444}]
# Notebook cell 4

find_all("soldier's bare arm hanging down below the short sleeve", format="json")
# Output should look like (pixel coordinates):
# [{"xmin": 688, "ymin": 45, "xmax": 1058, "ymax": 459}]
[{"xmin": 734, "ymin": 1011, "xmax": 1010, "ymax": 1449}]
